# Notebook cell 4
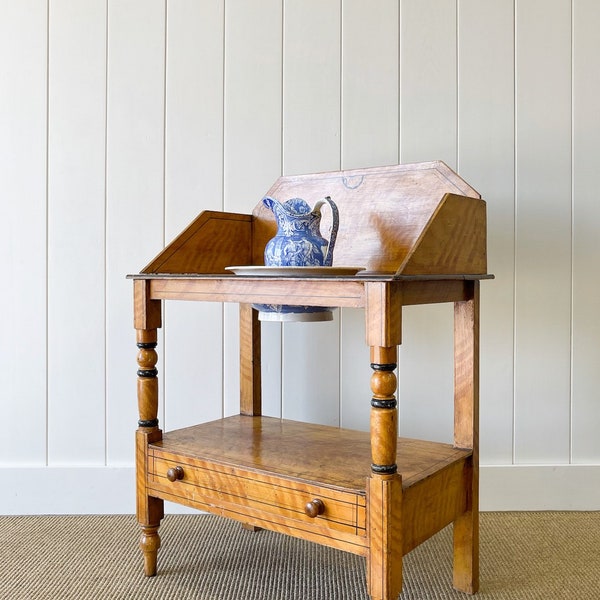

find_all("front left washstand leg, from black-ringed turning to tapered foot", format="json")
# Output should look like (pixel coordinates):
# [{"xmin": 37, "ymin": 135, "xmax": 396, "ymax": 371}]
[{"xmin": 136, "ymin": 329, "xmax": 164, "ymax": 577}]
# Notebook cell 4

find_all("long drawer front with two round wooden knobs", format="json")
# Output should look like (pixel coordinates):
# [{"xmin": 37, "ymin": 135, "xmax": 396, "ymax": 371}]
[{"xmin": 148, "ymin": 448, "xmax": 365, "ymax": 535}]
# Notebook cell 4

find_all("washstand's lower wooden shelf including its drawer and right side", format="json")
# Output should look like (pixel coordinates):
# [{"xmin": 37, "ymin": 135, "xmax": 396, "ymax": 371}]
[{"xmin": 147, "ymin": 415, "xmax": 471, "ymax": 554}]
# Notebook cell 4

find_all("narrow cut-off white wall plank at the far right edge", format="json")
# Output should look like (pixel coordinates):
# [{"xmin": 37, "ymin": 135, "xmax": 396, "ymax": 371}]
[{"xmin": 572, "ymin": 0, "xmax": 600, "ymax": 463}]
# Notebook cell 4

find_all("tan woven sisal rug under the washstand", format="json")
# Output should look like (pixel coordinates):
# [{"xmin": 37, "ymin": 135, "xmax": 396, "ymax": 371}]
[{"xmin": 0, "ymin": 513, "xmax": 600, "ymax": 600}]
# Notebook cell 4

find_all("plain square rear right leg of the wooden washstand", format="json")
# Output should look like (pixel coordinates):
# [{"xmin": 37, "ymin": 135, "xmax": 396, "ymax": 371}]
[{"xmin": 453, "ymin": 281, "xmax": 479, "ymax": 594}]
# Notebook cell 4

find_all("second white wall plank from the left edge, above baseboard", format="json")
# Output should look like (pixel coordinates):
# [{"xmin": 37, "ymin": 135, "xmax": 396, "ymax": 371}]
[{"xmin": 48, "ymin": 0, "xmax": 106, "ymax": 465}]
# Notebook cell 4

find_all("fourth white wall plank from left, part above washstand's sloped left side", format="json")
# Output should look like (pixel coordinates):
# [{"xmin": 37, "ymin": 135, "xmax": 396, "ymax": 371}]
[{"xmin": 165, "ymin": 0, "xmax": 225, "ymax": 216}]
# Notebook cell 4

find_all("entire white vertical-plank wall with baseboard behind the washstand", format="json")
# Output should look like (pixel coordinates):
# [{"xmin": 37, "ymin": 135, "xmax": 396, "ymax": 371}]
[{"xmin": 0, "ymin": 0, "xmax": 600, "ymax": 513}]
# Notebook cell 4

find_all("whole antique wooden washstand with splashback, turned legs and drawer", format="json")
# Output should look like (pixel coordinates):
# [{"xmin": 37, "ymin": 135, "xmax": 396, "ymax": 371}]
[{"xmin": 129, "ymin": 162, "xmax": 491, "ymax": 600}]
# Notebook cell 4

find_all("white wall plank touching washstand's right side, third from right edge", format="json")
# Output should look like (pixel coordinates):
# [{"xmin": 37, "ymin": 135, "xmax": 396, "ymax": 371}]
[{"xmin": 458, "ymin": 0, "xmax": 515, "ymax": 464}]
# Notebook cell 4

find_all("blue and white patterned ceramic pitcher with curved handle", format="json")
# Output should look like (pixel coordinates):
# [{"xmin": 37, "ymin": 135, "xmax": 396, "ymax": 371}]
[{"xmin": 263, "ymin": 196, "xmax": 339, "ymax": 267}]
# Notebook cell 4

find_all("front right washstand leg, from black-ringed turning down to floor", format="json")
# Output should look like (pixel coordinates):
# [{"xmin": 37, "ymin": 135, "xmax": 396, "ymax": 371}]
[{"xmin": 367, "ymin": 346, "xmax": 402, "ymax": 600}]
